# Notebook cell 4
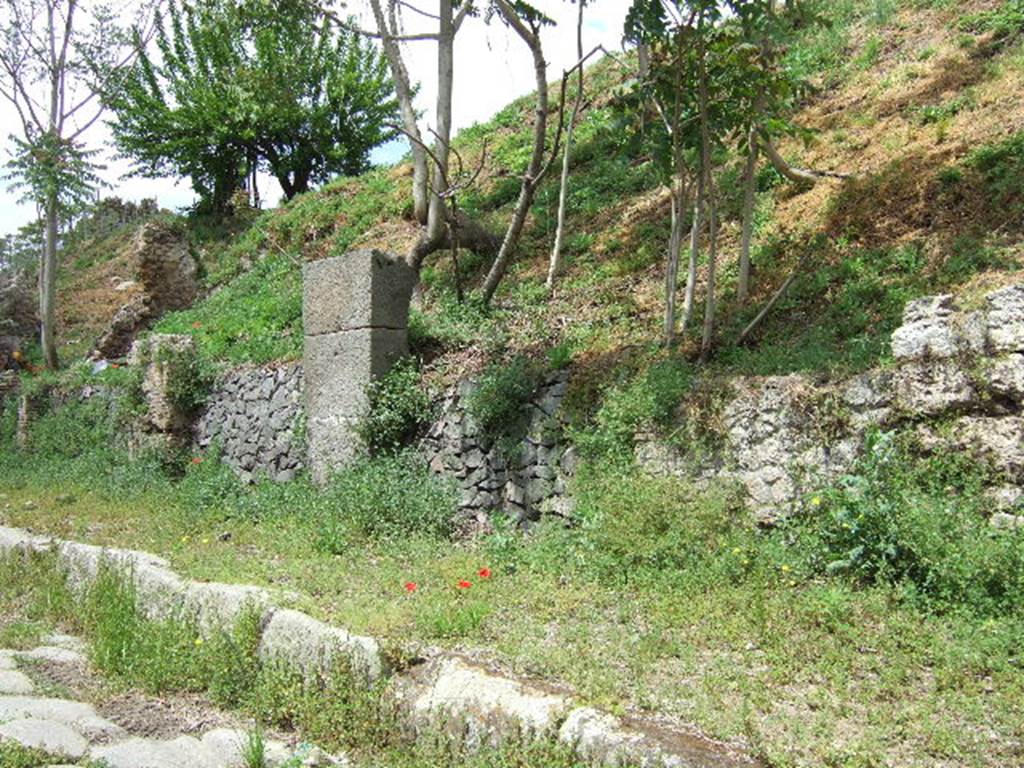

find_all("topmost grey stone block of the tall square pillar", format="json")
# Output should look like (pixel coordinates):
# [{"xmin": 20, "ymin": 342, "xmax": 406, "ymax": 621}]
[{"xmin": 302, "ymin": 250, "xmax": 416, "ymax": 336}]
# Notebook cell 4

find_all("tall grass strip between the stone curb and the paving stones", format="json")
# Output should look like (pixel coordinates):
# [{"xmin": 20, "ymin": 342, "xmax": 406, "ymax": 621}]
[{"xmin": 0, "ymin": 554, "xmax": 614, "ymax": 768}]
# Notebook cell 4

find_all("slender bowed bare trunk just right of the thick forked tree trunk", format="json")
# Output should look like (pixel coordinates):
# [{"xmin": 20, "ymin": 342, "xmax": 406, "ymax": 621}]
[{"xmin": 483, "ymin": 0, "xmax": 548, "ymax": 302}]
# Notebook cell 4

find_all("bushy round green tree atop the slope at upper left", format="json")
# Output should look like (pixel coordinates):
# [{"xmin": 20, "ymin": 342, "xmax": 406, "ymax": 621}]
[{"xmin": 110, "ymin": 0, "xmax": 397, "ymax": 209}]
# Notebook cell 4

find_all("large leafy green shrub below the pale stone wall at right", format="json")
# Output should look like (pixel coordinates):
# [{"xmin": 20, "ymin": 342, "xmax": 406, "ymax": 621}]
[{"xmin": 793, "ymin": 433, "xmax": 1024, "ymax": 614}]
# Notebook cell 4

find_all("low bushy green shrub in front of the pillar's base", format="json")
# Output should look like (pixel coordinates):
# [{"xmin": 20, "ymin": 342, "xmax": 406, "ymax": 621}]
[{"xmin": 312, "ymin": 453, "xmax": 456, "ymax": 553}]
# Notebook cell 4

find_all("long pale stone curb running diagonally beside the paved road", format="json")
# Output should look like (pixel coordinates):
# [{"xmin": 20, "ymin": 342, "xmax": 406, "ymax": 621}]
[{"xmin": 0, "ymin": 525, "xmax": 762, "ymax": 768}]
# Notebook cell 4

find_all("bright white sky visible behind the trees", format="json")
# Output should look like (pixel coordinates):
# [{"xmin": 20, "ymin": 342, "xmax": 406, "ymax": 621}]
[{"xmin": 0, "ymin": 0, "xmax": 630, "ymax": 234}]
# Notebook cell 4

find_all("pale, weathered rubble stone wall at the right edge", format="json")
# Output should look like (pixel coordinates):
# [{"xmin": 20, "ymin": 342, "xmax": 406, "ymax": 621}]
[{"xmin": 637, "ymin": 286, "xmax": 1024, "ymax": 520}]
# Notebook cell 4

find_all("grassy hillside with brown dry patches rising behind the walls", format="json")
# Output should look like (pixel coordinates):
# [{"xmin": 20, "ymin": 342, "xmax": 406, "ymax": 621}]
[{"xmin": 44, "ymin": 0, "xmax": 1003, "ymax": 391}]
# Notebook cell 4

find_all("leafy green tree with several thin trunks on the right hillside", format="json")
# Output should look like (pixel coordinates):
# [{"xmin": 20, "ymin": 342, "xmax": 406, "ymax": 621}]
[{"xmin": 626, "ymin": 0, "xmax": 800, "ymax": 355}]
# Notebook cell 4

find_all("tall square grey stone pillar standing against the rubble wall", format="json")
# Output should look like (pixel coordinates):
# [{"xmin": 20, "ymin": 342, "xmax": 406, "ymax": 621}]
[{"xmin": 302, "ymin": 251, "xmax": 416, "ymax": 483}]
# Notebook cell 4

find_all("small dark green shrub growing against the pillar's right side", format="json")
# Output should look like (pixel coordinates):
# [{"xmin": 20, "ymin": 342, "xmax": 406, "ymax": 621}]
[{"xmin": 358, "ymin": 357, "xmax": 433, "ymax": 454}]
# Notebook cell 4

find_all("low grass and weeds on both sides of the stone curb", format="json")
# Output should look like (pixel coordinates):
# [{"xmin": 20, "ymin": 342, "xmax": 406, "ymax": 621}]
[{"xmin": 0, "ymin": 409, "xmax": 1024, "ymax": 766}]
